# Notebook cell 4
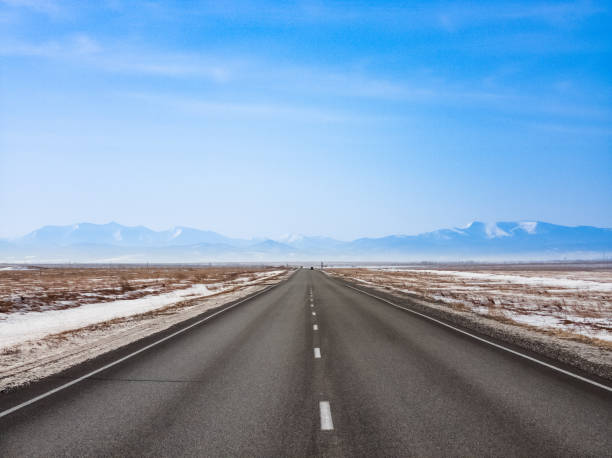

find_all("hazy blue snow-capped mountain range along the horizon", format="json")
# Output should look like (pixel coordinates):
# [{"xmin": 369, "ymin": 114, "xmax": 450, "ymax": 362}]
[{"xmin": 0, "ymin": 221, "xmax": 612, "ymax": 263}]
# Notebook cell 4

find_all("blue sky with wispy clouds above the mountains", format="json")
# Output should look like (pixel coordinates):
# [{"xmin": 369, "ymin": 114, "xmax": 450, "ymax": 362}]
[{"xmin": 0, "ymin": 0, "xmax": 612, "ymax": 239}]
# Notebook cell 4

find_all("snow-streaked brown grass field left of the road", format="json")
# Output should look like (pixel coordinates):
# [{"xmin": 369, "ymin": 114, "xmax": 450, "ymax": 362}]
[{"xmin": 0, "ymin": 268, "xmax": 288, "ymax": 391}]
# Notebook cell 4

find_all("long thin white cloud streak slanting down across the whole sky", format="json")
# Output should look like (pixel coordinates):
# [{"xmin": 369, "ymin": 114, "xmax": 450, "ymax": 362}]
[{"xmin": 0, "ymin": 34, "xmax": 612, "ymax": 121}]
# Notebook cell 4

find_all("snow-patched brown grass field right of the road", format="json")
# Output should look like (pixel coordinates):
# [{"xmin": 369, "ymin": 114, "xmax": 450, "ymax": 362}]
[{"xmin": 333, "ymin": 267, "xmax": 612, "ymax": 348}]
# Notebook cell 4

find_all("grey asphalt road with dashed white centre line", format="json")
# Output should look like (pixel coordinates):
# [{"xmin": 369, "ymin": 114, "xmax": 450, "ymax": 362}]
[{"xmin": 0, "ymin": 270, "xmax": 612, "ymax": 457}]
